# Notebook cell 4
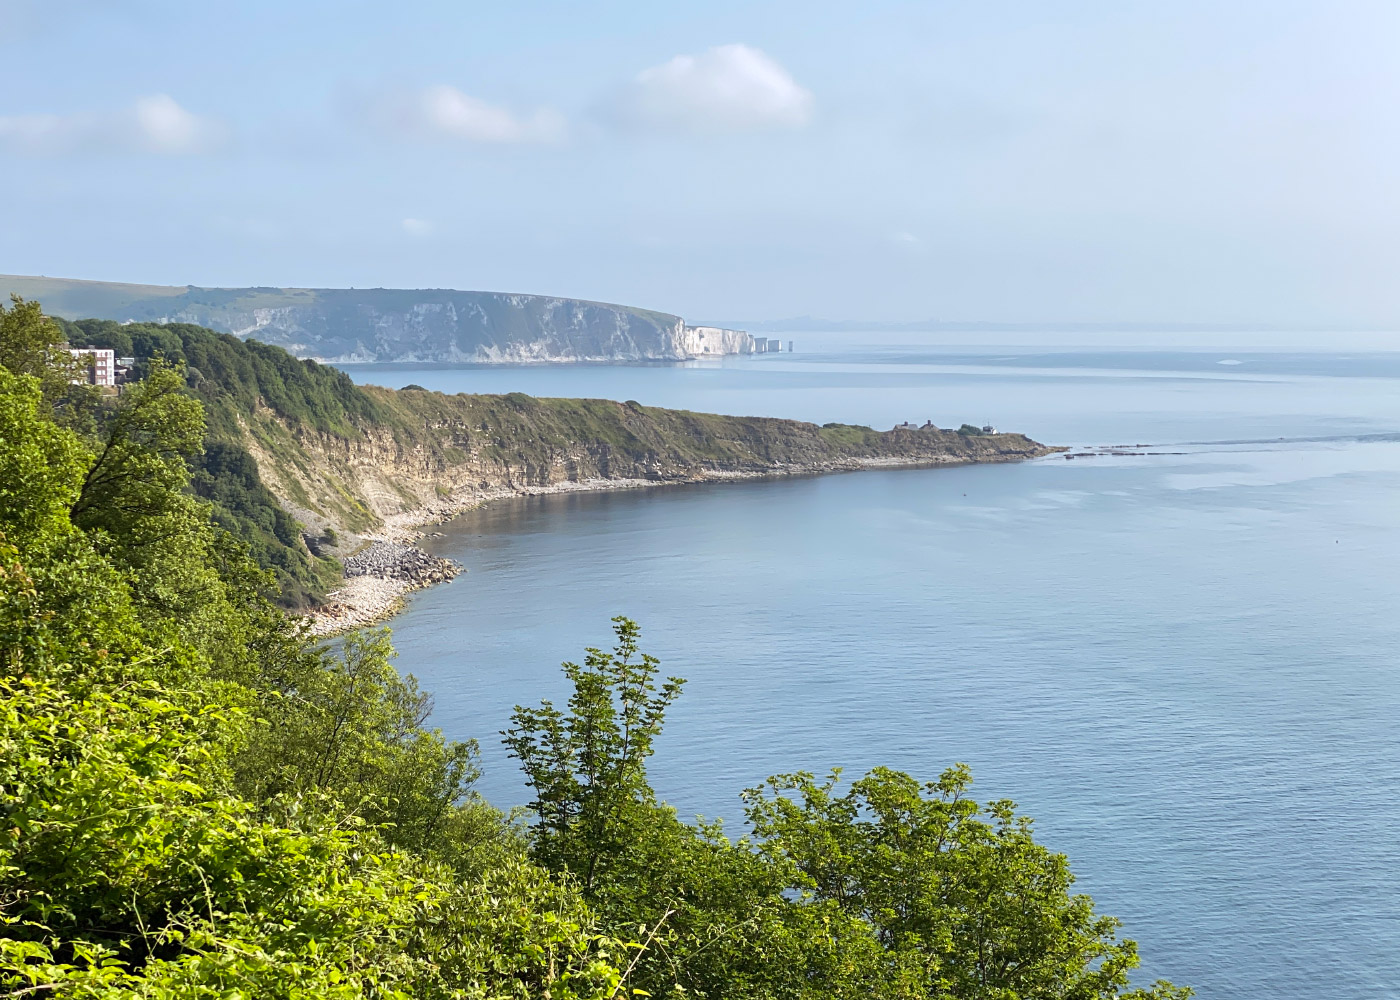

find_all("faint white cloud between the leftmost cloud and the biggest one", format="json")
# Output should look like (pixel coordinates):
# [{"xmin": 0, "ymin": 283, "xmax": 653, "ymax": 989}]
[{"xmin": 371, "ymin": 84, "xmax": 566, "ymax": 144}]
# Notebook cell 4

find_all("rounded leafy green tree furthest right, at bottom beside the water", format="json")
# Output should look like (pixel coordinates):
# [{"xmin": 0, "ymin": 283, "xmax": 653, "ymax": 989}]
[{"xmin": 745, "ymin": 765, "xmax": 1190, "ymax": 1000}]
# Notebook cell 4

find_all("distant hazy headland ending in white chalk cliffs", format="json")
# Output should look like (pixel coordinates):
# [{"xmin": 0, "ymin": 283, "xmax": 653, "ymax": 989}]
[{"xmin": 0, "ymin": 276, "xmax": 755, "ymax": 364}]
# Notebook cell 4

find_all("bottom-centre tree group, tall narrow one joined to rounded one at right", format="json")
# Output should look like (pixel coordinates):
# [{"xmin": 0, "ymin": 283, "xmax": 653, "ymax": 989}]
[{"xmin": 504, "ymin": 618, "xmax": 1189, "ymax": 1000}]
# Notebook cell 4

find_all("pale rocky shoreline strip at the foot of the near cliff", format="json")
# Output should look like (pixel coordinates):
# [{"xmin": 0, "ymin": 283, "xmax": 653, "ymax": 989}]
[{"xmin": 309, "ymin": 448, "xmax": 1064, "ymax": 636}]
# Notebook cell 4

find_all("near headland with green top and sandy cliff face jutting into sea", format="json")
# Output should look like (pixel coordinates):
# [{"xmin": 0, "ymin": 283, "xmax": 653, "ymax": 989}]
[{"xmin": 69, "ymin": 321, "xmax": 1046, "ymax": 605}]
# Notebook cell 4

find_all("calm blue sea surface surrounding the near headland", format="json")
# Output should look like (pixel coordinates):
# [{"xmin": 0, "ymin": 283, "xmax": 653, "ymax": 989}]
[{"xmin": 346, "ymin": 335, "xmax": 1400, "ymax": 1000}]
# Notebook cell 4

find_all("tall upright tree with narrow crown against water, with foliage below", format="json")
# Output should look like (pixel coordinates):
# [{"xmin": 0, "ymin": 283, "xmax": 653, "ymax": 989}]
[{"xmin": 503, "ymin": 618, "xmax": 878, "ymax": 999}]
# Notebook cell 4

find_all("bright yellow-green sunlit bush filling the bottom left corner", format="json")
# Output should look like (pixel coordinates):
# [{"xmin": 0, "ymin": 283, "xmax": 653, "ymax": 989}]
[{"xmin": 0, "ymin": 669, "xmax": 627, "ymax": 1000}]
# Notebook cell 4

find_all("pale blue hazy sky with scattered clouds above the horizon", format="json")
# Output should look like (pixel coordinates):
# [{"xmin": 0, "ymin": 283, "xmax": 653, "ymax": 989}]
[{"xmin": 0, "ymin": 0, "xmax": 1400, "ymax": 329}]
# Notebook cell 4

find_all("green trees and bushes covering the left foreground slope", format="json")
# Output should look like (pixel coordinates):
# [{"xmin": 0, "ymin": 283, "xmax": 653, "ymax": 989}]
[{"xmin": 0, "ymin": 329, "xmax": 630, "ymax": 999}]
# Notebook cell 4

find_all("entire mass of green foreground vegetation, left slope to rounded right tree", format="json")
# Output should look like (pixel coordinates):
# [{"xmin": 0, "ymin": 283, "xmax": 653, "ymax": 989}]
[{"xmin": 0, "ymin": 294, "xmax": 1187, "ymax": 1000}]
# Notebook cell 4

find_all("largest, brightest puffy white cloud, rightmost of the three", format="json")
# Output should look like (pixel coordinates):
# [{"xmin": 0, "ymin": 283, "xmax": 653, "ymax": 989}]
[{"xmin": 620, "ymin": 45, "xmax": 812, "ymax": 132}]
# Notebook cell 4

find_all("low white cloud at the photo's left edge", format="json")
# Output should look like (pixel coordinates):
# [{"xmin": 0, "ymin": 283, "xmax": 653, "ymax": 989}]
[{"xmin": 0, "ymin": 94, "xmax": 227, "ymax": 154}]
